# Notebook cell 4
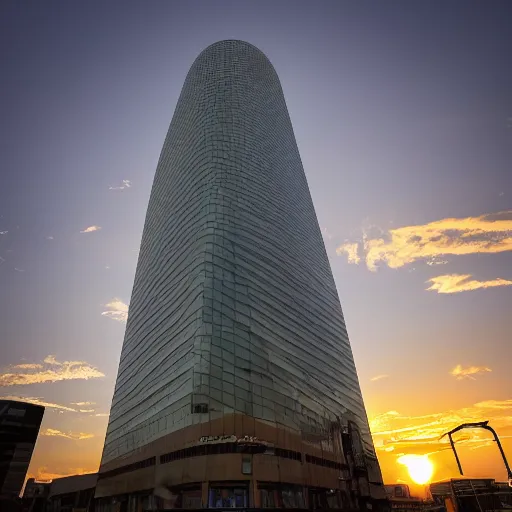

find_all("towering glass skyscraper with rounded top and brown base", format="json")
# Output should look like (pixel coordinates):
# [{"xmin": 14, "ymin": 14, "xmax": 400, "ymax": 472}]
[{"xmin": 96, "ymin": 41, "xmax": 384, "ymax": 510}]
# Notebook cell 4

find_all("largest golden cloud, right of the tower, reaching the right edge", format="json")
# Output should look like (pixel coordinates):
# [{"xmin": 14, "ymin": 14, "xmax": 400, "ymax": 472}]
[{"xmin": 337, "ymin": 210, "xmax": 512, "ymax": 271}]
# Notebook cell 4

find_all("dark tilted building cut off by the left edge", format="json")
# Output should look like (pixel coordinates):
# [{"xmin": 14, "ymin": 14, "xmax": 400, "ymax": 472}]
[{"xmin": 0, "ymin": 400, "xmax": 44, "ymax": 500}]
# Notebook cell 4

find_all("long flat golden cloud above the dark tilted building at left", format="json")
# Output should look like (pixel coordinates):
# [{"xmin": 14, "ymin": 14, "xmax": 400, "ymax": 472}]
[{"xmin": 0, "ymin": 356, "xmax": 105, "ymax": 386}]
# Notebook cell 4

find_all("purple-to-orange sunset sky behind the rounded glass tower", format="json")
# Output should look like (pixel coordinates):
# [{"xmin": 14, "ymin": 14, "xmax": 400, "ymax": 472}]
[{"xmin": 0, "ymin": 0, "xmax": 512, "ymax": 496}]
